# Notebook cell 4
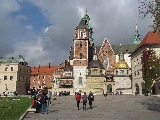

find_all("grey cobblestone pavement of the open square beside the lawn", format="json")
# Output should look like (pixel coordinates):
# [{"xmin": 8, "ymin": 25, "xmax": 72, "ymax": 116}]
[{"xmin": 24, "ymin": 95, "xmax": 160, "ymax": 120}]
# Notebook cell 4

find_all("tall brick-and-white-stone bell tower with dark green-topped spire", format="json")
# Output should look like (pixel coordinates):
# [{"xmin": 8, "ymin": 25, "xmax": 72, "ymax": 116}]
[{"xmin": 73, "ymin": 11, "xmax": 94, "ymax": 91}]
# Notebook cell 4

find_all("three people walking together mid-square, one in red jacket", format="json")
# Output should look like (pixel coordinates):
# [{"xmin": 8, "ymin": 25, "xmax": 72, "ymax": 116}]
[{"xmin": 75, "ymin": 91, "xmax": 94, "ymax": 110}]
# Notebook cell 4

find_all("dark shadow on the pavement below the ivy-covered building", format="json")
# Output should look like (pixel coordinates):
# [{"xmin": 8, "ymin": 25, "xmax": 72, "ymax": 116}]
[{"xmin": 141, "ymin": 96, "xmax": 160, "ymax": 112}]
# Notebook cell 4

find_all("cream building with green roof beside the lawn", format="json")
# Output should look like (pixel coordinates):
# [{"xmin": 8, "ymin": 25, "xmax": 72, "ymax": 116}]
[{"xmin": 0, "ymin": 56, "xmax": 30, "ymax": 95}]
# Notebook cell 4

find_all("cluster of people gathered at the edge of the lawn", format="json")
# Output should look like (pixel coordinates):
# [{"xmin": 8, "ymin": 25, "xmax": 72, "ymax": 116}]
[{"xmin": 32, "ymin": 90, "xmax": 52, "ymax": 114}]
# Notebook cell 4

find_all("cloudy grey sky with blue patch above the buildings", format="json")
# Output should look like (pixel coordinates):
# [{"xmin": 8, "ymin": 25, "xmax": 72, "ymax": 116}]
[{"xmin": 0, "ymin": 0, "xmax": 153, "ymax": 66}]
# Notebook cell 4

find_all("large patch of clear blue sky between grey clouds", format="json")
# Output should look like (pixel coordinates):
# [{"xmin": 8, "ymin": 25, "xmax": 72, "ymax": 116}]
[{"xmin": 11, "ymin": 1, "xmax": 50, "ymax": 33}]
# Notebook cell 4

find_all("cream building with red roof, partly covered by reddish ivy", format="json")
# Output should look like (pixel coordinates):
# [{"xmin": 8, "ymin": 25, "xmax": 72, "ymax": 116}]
[{"xmin": 131, "ymin": 31, "xmax": 160, "ymax": 95}]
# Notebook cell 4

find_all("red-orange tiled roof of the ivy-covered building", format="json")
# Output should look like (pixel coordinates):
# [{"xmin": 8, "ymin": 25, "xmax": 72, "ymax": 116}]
[{"xmin": 134, "ymin": 31, "xmax": 160, "ymax": 52}]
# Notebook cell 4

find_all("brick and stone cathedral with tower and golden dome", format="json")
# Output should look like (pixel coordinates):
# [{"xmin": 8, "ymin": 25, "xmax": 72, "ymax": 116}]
[{"xmin": 54, "ymin": 12, "xmax": 140, "ymax": 94}]
